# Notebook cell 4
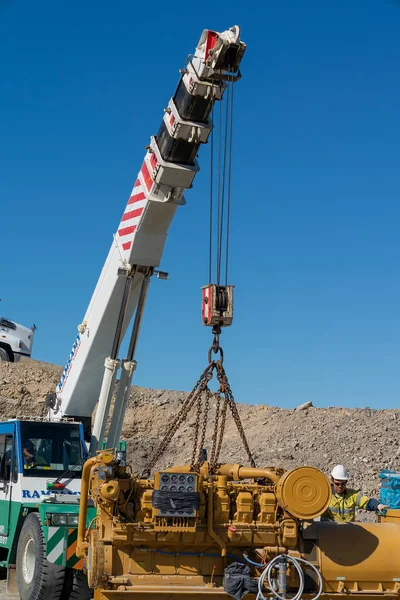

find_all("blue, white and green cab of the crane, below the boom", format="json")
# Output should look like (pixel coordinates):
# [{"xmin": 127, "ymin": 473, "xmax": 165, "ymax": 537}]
[{"xmin": 0, "ymin": 419, "xmax": 87, "ymax": 567}]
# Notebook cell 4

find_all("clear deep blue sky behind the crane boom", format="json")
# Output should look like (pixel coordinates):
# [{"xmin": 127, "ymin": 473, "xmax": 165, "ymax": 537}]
[{"xmin": 0, "ymin": 0, "xmax": 400, "ymax": 408}]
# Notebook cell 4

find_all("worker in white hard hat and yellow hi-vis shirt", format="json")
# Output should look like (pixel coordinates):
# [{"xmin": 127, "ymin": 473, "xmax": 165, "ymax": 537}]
[{"xmin": 321, "ymin": 465, "xmax": 390, "ymax": 523}]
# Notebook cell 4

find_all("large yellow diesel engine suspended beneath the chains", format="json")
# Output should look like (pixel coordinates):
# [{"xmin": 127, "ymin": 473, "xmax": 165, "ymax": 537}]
[{"xmin": 77, "ymin": 451, "xmax": 400, "ymax": 600}]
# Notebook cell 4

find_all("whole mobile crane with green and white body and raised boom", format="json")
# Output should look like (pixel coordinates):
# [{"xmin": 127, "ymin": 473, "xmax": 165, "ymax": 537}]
[{"xmin": 0, "ymin": 26, "xmax": 246, "ymax": 600}]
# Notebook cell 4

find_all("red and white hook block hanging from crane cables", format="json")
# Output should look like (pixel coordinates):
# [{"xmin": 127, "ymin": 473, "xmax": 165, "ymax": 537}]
[{"xmin": 201, "ymin": 283, "xmax": 235, "ymax": 327}]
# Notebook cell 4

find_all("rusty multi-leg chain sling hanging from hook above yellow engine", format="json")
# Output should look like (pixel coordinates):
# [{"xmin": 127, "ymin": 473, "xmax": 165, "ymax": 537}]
[{"xmin": 142, "ymin": 344, "xmax": 255, "ymax": 478}]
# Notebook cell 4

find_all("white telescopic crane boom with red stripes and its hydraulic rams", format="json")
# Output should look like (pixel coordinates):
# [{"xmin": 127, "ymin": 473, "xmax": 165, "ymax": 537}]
[{"xmin": 48, "ymin": 26, "xmax": 246, "ymax": 453}]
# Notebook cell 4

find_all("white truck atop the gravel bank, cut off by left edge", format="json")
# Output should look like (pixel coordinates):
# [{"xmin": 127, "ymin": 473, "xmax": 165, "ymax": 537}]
[{"xmin": 0, "ymin": 316, "xmax": 36, "ymax": 362}]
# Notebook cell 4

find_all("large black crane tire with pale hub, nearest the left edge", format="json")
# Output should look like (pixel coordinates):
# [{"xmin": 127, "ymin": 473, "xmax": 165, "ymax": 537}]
[{"xmin": 16, "ymin": 512, "xmax": 65, "ymax": 600}]
